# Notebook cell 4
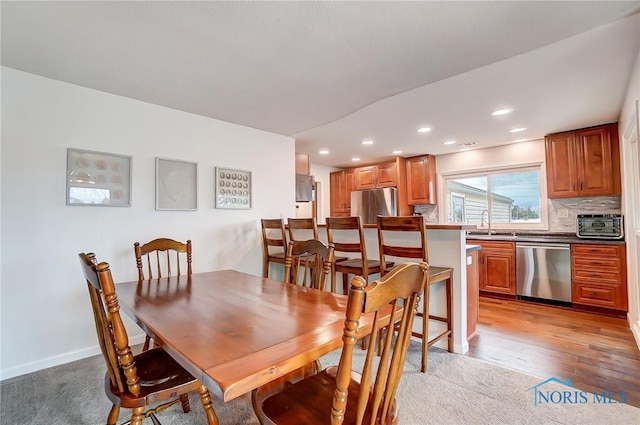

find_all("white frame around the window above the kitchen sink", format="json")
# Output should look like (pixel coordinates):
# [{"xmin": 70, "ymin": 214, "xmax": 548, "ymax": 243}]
[{"xmin": 438, "ymin": 161, "xmax": 549, "ymax": 230}]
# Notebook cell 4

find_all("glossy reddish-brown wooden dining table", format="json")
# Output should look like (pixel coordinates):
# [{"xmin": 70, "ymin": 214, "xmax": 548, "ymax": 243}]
[{"xmin": 116, "ymin": 270, "xmax": 388, "ymax": 401}]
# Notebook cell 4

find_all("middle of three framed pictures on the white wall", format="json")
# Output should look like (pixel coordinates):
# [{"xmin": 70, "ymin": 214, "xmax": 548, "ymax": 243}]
[{"xmin": 156, "ymin": 158, "xmax": 198, "ymax": 211}]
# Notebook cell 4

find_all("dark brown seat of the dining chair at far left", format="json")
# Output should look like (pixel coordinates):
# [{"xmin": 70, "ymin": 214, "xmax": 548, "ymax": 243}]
[{"xmin": 105, "ymin": 348, "xmax": 202, "ymax": 408}]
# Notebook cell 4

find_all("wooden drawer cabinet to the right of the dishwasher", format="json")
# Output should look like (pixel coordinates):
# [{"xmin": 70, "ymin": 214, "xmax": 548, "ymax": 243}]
[{"xmin": 571, "ymin": 244, "xmax": 628, "ymax": 312}]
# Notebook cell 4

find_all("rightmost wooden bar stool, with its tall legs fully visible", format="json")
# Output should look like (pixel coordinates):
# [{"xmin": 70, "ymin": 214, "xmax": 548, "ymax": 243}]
[{"xmin": 377, "ymin": 215, "xmax": 453, "ymax": 372}]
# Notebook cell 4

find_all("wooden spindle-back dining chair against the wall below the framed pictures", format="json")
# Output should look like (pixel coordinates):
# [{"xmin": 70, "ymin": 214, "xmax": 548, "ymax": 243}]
[{"xmin": 133, "ymin": 238, "xmax": 192, "ymax": 351}]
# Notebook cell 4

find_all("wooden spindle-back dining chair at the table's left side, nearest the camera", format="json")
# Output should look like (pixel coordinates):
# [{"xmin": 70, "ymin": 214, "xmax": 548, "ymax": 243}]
[{"xmin": 79, "ymin": 253, "xmax": 218, "ymax": 425}]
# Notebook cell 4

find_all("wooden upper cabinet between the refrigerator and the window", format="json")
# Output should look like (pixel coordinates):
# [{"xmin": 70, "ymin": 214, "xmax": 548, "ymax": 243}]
[{"xmin": 406, "ymin": 155, "xmax": 437, "ymax": 205}]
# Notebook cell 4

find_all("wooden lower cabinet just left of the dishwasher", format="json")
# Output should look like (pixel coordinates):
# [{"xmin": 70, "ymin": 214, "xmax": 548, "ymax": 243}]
[{"xmin": 467, "ymin": 239, "xmax": 516, "ymax": 298}]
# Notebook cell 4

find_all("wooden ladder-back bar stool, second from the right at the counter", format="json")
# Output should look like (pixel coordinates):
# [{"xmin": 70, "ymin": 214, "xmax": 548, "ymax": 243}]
[{"xmin": 326, "ymin": 216, "xmax": 393, "ymax": 294}]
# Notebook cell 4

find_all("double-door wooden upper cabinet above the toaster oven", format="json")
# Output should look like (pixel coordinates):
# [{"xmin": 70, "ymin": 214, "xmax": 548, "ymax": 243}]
[{"xmin": 545, "ymin": 123, "xmax": 620, "ymax": 198}]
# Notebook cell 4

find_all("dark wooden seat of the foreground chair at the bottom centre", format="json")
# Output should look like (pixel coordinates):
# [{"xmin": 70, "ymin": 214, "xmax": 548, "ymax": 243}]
[{"xmin": 262, "ymin": 366, "xmax": 398, "ymax": 425}]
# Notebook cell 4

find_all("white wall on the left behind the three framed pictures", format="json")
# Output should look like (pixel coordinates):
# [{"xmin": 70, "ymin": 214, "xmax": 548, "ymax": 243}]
[{"xmin": 0, "ymin": 68, "xmax": 295, "ymax": 378}]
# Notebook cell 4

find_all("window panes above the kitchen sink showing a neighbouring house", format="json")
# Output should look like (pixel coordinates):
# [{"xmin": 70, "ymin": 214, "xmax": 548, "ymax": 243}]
[{"xmin": 445, "ymin": 166, "xmax": 546, "ymax": 228}]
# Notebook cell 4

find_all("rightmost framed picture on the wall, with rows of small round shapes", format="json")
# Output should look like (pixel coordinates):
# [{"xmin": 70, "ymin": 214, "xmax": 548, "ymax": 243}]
[{"xmin": 215, "ymin": 167, "xmax": 251, "ymax": 210}]
